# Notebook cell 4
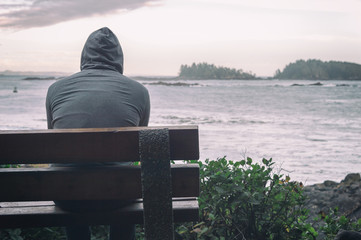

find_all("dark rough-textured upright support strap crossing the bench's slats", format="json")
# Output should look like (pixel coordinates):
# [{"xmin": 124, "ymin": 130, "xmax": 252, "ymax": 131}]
[{"xmin": 139, "ymin": 129, "xmax": 174, "ymax": 240}]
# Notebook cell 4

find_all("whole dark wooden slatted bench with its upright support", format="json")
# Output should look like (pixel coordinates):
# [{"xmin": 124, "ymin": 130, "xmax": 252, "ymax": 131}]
[{"xmin": 0, "ymin": 126, "xmax": 199, "ymax": 239}]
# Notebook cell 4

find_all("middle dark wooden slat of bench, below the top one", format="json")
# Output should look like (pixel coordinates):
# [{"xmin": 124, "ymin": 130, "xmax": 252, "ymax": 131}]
[{"xmin": 0, "ymin": 164, "xmax": 199, "ymax": 201}]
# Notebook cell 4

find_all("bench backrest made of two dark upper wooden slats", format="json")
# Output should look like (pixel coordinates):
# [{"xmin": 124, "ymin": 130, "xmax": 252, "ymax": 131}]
[{"xmin": 0, "ymin": 126, "xmax": 199, "ymax": 201}]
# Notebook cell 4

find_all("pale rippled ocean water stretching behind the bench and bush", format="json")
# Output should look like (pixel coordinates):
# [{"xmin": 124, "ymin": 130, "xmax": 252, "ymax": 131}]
[{"xmin": 0, "ymin": 76, "xmax": 361, "ymax": 185}]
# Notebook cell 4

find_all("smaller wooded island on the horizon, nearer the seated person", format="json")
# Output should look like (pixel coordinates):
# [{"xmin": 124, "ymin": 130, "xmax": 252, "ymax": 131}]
[{"xmin": 178, "ymin": 62, "xmax": 257, "ymax": 80}]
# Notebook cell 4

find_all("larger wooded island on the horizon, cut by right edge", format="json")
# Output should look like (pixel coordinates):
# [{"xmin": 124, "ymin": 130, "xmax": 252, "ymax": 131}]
[{"xmin": 274, "ymin": 59, "xmax": 361, "ymax": 80}]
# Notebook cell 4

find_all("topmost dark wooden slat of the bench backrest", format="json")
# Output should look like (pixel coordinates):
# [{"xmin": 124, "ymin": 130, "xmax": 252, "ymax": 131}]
[{"xmin": 0, "ymin": 126, "xmax": 199, "ymax": 164}]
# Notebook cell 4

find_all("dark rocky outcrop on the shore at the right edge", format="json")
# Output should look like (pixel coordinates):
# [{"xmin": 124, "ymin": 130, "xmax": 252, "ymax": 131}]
[{"xmin": 304, "ymin": 173, "xmax": 361, "ymax": 219}]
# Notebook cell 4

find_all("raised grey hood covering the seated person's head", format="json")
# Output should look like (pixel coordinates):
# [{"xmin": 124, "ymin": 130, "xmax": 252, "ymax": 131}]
[{"xmin": 80, "ymin": 27, "xmax": 123, "ymax": 74}]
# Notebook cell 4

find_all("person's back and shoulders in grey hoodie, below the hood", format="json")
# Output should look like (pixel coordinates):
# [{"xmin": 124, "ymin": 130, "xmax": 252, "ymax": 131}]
[{"xmin": 47, "ymin": 69, "xmax": 149, "ymax": 128}]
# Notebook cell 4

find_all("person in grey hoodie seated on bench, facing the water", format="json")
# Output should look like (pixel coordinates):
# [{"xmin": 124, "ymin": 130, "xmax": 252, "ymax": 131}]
[{"xmin": 46, "ymin": 27, "xmax": 150, "ymax": 240}]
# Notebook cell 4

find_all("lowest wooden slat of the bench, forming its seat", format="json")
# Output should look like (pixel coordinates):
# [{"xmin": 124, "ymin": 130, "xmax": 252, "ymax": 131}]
[{"xmin": 0, "ymin": 198, "xmax": 199, "ymax": 228}]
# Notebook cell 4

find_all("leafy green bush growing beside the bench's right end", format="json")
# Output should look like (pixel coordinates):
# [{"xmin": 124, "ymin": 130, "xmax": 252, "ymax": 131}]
[{"xmin": 178, "ymin": 158, "xmax": 317, "ymax": 240}]
